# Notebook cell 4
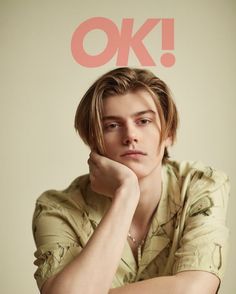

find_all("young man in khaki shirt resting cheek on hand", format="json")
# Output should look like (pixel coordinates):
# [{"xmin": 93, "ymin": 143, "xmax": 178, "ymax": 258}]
[{"xmin": 33, "ymin": 68, "xmax": 229, "ymax": 294}]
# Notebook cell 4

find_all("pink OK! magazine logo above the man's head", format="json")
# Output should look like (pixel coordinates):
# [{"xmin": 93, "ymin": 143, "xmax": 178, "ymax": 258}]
[{"xmin": 71, "ymin": 17, "xmax": 175, "ymax": 67}]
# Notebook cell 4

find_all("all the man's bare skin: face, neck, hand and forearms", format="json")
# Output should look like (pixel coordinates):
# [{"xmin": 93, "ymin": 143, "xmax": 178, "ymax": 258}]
[{"xmin": 42, "ymin": 91, "xmax": 219, "ymax": 294}]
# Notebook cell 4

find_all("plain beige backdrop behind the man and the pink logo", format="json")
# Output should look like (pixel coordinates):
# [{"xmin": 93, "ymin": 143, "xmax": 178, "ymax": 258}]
[{"xmin": 0, "ymin": 0, "xmax": 236, "ymax": 294}]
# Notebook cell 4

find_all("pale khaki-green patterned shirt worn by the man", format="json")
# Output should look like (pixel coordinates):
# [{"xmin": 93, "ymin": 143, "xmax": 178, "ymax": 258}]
[{"xmin": 33, "ymin": 161, "xmax": 229, "ymax": 288}]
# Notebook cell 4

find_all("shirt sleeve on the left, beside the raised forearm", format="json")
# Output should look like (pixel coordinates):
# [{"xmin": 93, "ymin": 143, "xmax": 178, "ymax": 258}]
[{"xmin": 33, "ymin": 196, "xmax": 82, "ymax": 289}]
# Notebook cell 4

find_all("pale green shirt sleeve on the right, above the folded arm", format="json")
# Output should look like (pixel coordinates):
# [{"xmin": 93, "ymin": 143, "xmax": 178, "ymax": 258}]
[{"xmin": 173, "ymin": 175, "xmax": 229, "ymax": 280}]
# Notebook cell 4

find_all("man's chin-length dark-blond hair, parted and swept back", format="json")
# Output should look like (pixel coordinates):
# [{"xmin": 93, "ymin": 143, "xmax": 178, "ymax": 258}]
[{"xmin": 74, "ymin": 67, "xmax": 178, "ymax": 161}]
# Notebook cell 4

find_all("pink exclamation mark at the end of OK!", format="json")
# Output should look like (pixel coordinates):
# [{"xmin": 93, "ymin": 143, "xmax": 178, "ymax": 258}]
[{"xmin": 161, "ymin": 18, "xmax": 175, "ymax": 67}]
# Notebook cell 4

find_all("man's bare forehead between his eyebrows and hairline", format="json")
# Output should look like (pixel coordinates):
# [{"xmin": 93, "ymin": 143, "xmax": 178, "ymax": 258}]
[{"xmin": 103, "ymin": 90, "xmax": 157, "ymax": 117}]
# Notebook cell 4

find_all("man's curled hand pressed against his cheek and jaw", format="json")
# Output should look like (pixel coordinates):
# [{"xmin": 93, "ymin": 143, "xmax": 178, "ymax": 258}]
[{"xmin": 88, "ymin": 152, "xmax": 140, "ymax": 198}]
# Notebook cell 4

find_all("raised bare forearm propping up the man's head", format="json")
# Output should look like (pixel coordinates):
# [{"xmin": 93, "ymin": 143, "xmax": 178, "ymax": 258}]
[{"xmin": 43, "ymin": 188, "xmax": 138, "ymax": 294}]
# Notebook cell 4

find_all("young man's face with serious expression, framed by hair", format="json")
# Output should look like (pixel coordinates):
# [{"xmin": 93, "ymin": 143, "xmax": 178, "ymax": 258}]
[{"xmin": 103, "ymin": 90, "xmax": 170, "ymax": 178}]
